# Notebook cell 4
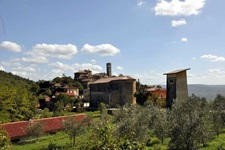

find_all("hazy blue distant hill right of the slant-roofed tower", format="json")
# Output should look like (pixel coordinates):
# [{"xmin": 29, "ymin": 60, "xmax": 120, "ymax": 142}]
[{"xmin": 188, "ymin": 84, "xmax": 225, "ymax": 101}]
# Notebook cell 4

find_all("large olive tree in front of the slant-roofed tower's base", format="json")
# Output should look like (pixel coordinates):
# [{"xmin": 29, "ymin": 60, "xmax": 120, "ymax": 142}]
[{"xmin": 169, "ymin": 95, "xmax": 210, "ymax": 150}]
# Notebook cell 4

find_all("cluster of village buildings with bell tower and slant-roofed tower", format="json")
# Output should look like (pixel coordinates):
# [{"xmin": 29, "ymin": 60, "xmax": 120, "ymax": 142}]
[{"xmin": 37, "ymin": 63, "xmax": 190, "ymax": 110}]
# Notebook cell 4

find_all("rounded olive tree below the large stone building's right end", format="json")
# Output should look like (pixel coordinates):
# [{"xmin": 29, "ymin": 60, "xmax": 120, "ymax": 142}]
[{"xmin": 114, "ymin": 105, "xmax": 153, "ymax": 142}]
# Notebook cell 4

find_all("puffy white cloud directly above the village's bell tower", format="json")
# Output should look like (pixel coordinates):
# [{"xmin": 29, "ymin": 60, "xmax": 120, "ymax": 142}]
[{"xmin": 81, "ymin": 44, "xmax": 120, "ymax": 56}]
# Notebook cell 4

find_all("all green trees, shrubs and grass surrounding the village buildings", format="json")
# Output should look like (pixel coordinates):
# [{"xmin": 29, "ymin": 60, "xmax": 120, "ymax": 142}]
[{"xmin": 0, "ymin": 72, "xmax": 225, "ymax": 150}]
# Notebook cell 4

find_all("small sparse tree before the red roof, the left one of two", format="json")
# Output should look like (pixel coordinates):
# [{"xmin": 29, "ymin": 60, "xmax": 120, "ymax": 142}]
[{"xmin": 25, "ymin": 120, "xmax": 44, "ymax": 140}]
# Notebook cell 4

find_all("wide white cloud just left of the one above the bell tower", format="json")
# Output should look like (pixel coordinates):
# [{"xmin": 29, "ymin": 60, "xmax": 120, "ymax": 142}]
[{"xmin": 27, "ymin": 43, "xmax": 78, "ymax": 59}]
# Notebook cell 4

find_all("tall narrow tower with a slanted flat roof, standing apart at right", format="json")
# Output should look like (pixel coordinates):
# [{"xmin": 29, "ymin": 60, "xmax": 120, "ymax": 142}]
[{"xmin": 164, "ymin": 68, "xmax": 190, "ymax": 109}]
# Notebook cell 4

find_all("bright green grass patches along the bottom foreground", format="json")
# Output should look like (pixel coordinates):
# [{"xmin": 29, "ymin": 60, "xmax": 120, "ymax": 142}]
[{"xmin": 4, "ymin": 111, "xmax": 225, "ymax": 150}]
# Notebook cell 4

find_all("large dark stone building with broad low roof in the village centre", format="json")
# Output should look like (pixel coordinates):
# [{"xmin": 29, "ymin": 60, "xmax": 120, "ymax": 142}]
[{"xmin": 89, "ymin": 76, "xmax": 136, "ymax": 108}]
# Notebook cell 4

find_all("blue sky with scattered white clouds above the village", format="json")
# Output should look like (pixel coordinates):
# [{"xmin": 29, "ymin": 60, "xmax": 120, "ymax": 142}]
[{"xmin": 0, "ymin": 0, "xmax": 225, "ymax": 85}]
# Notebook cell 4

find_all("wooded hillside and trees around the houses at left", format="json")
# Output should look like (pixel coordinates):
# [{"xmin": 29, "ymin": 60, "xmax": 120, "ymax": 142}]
[{"xmin": 0, "ymin": 71, "xmax": 84, "ymax": 123}]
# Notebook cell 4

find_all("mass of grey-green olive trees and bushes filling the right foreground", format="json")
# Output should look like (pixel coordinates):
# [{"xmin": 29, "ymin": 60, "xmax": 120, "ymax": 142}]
[{"xmin": 54, "ymin": 95, "xmax": 225, "ymax": 150}]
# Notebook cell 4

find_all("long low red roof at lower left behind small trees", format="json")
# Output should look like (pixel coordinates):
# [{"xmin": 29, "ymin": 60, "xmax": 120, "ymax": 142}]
[{"xmin": 0, "ymin": 114, "xmax": 87, "ymax": 139}]
